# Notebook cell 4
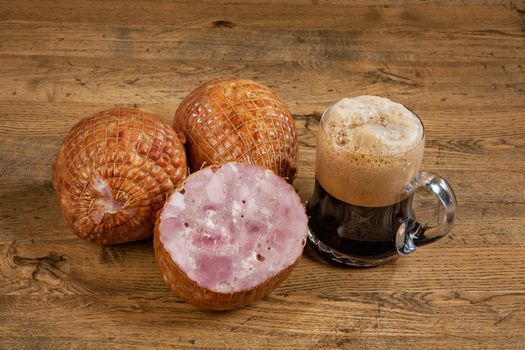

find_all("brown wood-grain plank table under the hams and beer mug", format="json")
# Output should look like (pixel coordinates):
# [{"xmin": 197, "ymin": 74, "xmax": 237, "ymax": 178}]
[{"xmin": 0, "ymin": 0, "xmax": 525, "ymax": 349}]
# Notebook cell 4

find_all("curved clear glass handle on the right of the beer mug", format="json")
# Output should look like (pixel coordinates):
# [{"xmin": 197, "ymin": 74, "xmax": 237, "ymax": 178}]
[{"xmin": 395, "ymin": 172, "xmax": 457, "ymax": 255}]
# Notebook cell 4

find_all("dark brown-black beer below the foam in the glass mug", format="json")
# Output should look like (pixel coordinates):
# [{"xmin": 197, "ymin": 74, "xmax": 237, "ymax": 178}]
[{"xmin": 307, "ymin": 180, "xmax": 413, "ymax": 259}]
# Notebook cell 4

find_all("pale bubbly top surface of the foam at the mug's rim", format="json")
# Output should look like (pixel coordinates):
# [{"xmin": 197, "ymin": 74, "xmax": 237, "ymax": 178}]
[{"xmin": 322, "ymin": 96, "xmax": 423, "ymax": 156}]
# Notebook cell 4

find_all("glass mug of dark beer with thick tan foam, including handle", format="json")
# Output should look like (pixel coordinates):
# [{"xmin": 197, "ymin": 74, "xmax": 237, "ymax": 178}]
[{"xmin": 306, "ymin": 96, "xmax": 457, "ymax": 267}]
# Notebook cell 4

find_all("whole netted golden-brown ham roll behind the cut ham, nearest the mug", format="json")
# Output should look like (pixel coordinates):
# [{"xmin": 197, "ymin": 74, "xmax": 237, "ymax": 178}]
[{"xmin": 173, "ymin": 78, "xmax": 298, "ymax": 183}]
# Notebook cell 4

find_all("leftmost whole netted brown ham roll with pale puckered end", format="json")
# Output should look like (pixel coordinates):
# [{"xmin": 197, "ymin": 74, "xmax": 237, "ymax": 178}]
[{"xmin": 53, "ymin": 108, "xmax": 187, "ymax": 244}]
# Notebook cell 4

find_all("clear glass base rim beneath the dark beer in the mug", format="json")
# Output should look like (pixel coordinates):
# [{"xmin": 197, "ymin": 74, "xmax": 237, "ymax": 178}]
[{"xmin": 308, "ymin": 227, "xmax": 399, "ymax": 267}]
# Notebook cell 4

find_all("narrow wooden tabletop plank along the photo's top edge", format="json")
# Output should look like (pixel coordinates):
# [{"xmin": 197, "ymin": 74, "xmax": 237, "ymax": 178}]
[{"xmin": 0, "ymin": 0, "xmax": 521, "ymax": 30}]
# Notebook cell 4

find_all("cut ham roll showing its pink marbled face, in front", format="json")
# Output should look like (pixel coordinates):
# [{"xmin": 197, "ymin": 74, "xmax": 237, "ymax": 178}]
[{"xmin": 155, "ymin": 163, "xmax": 307, "ymax": 309}]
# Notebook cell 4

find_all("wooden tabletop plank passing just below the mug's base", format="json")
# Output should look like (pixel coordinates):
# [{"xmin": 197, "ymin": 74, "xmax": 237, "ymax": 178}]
[{"xmin": 0, "ymin": 241, "xmax": 525, "ymax": 296}]
